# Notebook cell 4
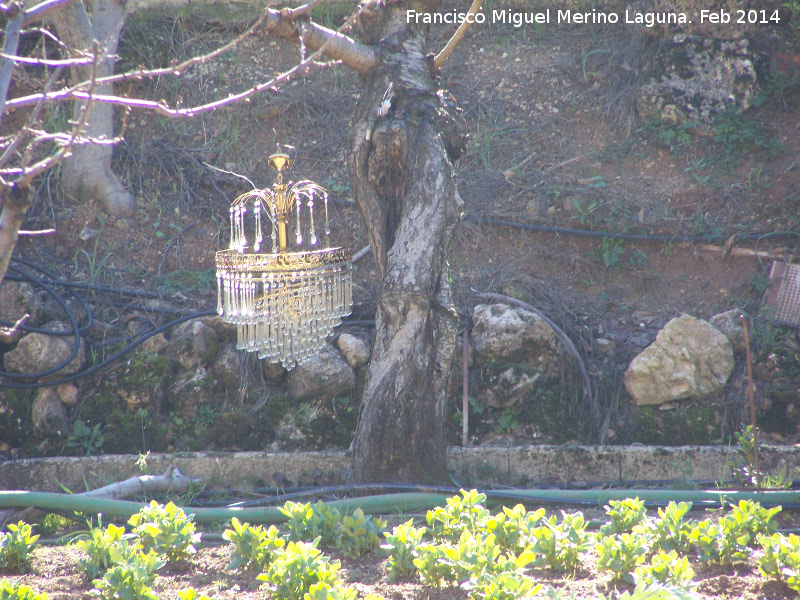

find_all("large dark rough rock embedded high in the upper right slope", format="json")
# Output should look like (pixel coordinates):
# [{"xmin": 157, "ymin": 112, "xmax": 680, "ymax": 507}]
[{"xmin": 636, "ymin": 35, "xmax": 756, "ymax": 125}]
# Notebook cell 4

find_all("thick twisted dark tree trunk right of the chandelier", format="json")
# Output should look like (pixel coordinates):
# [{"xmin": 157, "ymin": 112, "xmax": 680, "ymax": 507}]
[{"xmin": 350, "ymin": 3, "xmax": 465, "ymax": 483}]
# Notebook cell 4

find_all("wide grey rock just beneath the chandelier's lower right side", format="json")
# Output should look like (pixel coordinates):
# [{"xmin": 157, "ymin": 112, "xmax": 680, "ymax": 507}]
[{"xmin": 289, "ymin": 345, "xmax": 356, "ymax": 400}]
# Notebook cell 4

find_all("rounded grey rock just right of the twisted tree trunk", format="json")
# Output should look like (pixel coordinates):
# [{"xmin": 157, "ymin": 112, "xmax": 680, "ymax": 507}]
[{"xmin": 472, "ymin": 304, "xmax": 563, "ymax": 372}]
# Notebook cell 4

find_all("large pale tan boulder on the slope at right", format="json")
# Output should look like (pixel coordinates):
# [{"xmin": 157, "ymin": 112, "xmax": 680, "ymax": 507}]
[{"xmin": 624, "ymin": 315, "xmax": 733, "ymax": 406}]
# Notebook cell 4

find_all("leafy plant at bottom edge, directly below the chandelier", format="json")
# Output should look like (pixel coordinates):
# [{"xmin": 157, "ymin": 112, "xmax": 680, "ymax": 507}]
[{"xmin": 257, "ymin": 537, "xmax": 341, "ymax": 600}]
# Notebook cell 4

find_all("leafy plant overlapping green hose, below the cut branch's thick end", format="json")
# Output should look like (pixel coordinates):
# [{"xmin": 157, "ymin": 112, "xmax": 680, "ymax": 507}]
[{"xmin": 128, "ymin": 500, "xmax": 200, "ymax": 562}]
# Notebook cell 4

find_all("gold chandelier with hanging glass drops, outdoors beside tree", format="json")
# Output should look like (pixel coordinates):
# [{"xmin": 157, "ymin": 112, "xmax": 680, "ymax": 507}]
[{"xmin": 216, "ymin": 152, "xmax": 353, "ymax": 369}]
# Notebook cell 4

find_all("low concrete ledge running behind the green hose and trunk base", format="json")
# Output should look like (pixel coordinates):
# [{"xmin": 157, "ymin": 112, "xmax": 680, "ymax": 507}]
[{"xmin": 0, "ymin": 446, "xmax": 800, "ymax": 493}]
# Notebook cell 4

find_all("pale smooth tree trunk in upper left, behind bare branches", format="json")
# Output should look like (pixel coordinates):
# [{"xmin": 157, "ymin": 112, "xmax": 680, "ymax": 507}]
[{"xmin": 53, "ymin": 0, "xmax": 135, "ymax": 217}]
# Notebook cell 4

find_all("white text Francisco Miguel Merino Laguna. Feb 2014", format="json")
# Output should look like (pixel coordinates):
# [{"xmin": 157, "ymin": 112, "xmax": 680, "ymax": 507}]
[{"xmin": 406, "ymin": 8, "xmax": 780, "ymax": 27}]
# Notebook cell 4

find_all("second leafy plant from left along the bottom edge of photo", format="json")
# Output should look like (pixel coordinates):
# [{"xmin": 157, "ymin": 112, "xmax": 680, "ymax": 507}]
[{"xmin": 89, "ymin": 545, "xmax": 166, "ymax": 600}]
